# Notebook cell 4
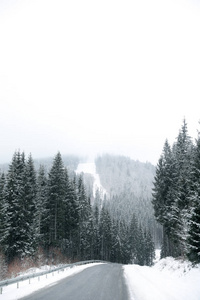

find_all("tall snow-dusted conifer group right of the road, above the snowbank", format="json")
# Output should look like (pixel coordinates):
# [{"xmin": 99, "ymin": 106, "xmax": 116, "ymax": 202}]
[{"xmin": 153, "ymin": 120, "xmax": 200, "ymax": 263}]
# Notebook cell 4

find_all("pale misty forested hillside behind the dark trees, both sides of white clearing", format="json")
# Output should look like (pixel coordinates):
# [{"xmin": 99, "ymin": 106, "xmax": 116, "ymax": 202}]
[{"xmin": 0, "ymin": 154, "xmax": 160, "ymax": 244}]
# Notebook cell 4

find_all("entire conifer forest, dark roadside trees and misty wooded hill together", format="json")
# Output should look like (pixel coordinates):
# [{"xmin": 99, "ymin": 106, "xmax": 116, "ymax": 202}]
[{"xmin": 0, "ymin": 120, "xmax": 200, "ymax": 278}]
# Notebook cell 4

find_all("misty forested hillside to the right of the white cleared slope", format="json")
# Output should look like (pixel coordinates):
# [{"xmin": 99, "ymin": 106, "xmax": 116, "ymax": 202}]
[{"xmin": 95, "ymin": 154, "xmax": 161, "ymax": 246}]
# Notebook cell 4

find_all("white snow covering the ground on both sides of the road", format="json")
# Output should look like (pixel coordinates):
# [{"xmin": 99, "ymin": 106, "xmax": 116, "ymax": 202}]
[{"xmin": 0, "ymin": 257, "xmax": 200, "ymax": 300}]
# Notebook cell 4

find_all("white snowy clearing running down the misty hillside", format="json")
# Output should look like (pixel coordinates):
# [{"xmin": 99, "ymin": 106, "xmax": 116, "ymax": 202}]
[{"xmin": 76, "ymin": 162, "xmax": 107, "ymax": 198}]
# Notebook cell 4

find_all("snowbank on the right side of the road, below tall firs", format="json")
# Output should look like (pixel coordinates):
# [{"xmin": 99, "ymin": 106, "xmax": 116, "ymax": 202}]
[{"xmin": 124, "ymin": 257, "xmax": 200, "ymax": 300}]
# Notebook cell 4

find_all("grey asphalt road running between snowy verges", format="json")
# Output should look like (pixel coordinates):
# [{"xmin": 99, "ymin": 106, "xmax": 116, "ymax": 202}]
[{"xmin": 21, "ymin": 264, "xmax": 129, "ymax": 300}]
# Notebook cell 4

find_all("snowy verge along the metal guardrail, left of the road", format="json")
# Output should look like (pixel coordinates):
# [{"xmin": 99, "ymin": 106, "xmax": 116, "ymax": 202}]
[{"xmin": 0, "ymin": 263, "xmax": 99, "ymax": 300}]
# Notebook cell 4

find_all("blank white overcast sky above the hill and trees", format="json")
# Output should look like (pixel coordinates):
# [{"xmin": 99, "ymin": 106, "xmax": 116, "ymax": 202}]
[{"xmin": 0, "ymin": 0, "xmax": 200, "ymax": 164}]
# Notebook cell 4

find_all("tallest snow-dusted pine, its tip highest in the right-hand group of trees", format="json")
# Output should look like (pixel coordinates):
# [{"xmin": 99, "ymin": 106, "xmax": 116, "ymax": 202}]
[{"xmin": 172, "ymin": 120, "xmax": 194, "ymax": 255}]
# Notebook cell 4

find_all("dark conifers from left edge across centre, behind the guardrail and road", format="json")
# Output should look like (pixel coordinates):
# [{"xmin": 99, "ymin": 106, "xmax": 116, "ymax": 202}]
[{"xmin": 0, "ymin": 151, "xmax": 154, "ymax": 278}]
